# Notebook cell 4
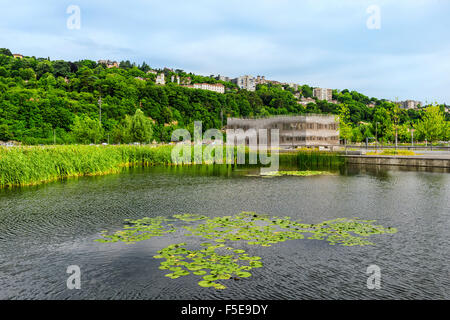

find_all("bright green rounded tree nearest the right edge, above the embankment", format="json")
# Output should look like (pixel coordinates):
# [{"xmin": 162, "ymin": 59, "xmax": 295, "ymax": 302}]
[{"xmin": 415, "ymin": 105, "xmax": 447, "ymax": 143}]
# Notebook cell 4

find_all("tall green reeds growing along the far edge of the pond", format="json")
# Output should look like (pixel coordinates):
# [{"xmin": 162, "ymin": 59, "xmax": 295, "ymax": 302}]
[{"xmin": 0, "ymin": 145, "xmax": 343, "ymax": 187}]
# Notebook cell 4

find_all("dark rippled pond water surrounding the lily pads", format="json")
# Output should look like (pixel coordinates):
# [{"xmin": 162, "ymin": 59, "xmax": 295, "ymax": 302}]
[{"xmin": 0, "ymin": 166, "xmax": 450, "ymax": 300}]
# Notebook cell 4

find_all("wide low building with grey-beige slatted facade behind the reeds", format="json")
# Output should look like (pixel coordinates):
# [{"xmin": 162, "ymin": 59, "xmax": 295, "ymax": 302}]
[{"xmin": 227, "ymin": 114, "xmax": 339, "ymax": 148}]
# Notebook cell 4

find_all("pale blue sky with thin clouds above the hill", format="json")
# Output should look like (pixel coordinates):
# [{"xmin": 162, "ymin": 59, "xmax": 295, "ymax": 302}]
[{"xmin": 0, "ymin": 0, "xmax": 450, "ymax": 104}]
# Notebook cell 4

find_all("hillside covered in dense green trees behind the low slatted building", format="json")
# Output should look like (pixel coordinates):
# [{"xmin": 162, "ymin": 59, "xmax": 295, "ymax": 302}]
[{"xmin": 0, "ymin": 49, "xmax": 448, "ymax": 144}]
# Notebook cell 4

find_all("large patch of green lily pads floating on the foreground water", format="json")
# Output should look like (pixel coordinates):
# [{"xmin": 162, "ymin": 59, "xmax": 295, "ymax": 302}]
[{"xmin": 96, "ymin": 212, "xmax": 397, "ymax": 290}]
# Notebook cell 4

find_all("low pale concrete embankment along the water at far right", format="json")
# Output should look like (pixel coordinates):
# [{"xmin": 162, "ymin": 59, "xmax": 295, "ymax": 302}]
[{"xmin": 344, "ymin": 155, "xmax": 450, "ymax": 168}]
